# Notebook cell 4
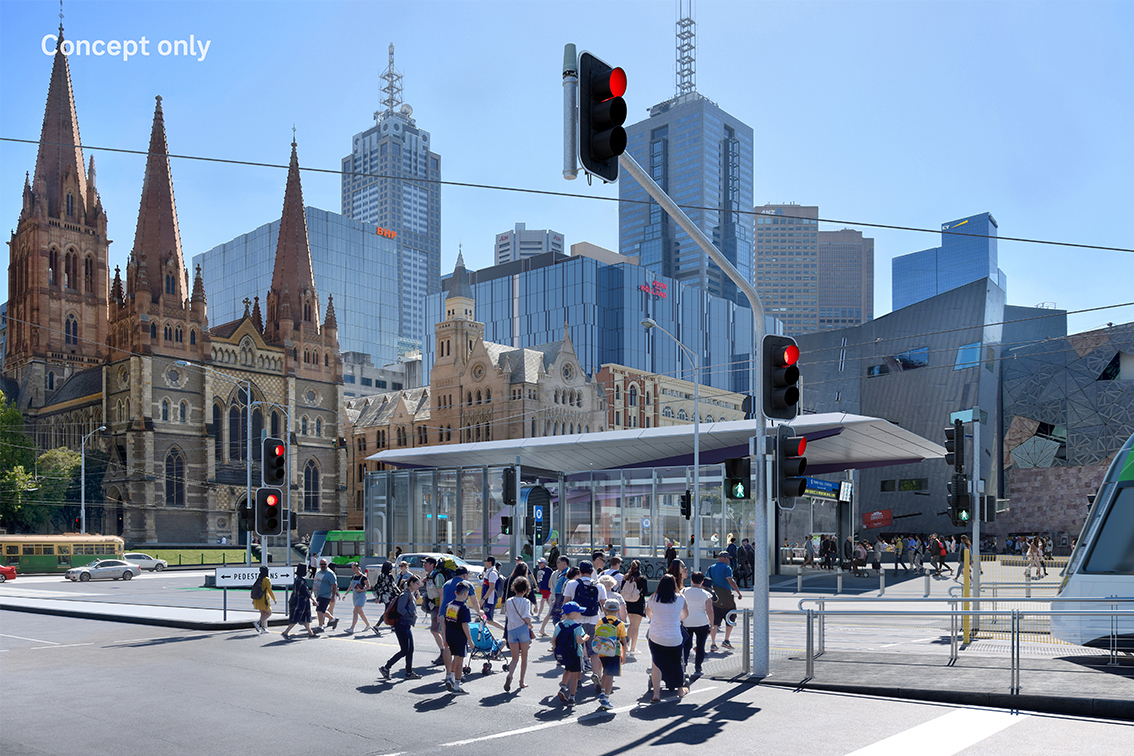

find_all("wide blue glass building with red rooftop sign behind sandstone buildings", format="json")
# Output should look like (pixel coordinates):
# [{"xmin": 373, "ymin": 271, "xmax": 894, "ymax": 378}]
[{"xmin": 422, "ymin": 253, "xmax": 782, "ymax": 393}]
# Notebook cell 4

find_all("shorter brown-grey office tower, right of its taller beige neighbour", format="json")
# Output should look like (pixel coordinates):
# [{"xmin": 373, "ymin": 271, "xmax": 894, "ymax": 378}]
[{"xmin": 816, "ymin": 228, "xmax": 874, "ymax": 331}]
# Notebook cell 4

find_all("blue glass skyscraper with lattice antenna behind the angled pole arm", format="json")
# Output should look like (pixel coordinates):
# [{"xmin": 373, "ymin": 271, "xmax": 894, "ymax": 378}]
[{"xmin": 618, "ymin": 6, "xmax": 753, "ymax": 306}]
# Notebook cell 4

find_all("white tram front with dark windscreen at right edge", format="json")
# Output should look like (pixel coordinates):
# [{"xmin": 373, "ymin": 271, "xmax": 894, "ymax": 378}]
[{"xmin": 1051, "ymin": 436, "xmax": 1134, "ymax": 652}]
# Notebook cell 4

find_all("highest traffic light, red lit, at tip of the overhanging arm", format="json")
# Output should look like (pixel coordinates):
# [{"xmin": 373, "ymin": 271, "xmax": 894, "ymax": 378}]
[{"xmin": 578, "ymin": 52, "xmax": 626, "ymax": 181}]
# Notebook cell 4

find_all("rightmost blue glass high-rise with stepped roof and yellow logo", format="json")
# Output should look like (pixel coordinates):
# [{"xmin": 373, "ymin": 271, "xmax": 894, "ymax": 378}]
[{"xmin": 891, "ymin": 213, "xmax": 1008, "ymax": 309}]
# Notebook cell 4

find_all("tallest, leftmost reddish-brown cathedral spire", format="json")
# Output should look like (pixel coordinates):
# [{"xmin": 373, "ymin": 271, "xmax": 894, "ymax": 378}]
[{"xmin": 32, "ymin": 22, "xmax": 86, "ymax": 222}]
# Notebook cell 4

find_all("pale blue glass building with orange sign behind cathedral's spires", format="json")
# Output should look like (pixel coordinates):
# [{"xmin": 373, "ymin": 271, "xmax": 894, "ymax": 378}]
[{"xmin": 193, "ymin": 206, "xmax": 399, "ymax": 365}]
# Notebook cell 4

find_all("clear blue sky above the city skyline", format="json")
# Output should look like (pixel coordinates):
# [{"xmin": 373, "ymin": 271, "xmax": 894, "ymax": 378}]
[{"xmin": 0, "ymin": 0, "xmax": 1134, "ymax": 331}]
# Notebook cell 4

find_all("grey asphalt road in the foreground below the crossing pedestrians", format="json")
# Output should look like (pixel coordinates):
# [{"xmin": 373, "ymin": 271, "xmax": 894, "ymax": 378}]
[{"xmin": 0, "ymin": 611, "xmax": 1134, "ymax": 756}]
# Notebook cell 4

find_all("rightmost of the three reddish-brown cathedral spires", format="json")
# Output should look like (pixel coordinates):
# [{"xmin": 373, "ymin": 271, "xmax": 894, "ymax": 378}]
[{"xmin": 268, "ymin": 141, "xmax": 319, "ymax": 341}]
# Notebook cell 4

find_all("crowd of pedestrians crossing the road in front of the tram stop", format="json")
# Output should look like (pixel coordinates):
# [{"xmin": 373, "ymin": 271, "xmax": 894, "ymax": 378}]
[{"xmin": 258, "ymin": 546, "xmax": 754, "ymax": 710}]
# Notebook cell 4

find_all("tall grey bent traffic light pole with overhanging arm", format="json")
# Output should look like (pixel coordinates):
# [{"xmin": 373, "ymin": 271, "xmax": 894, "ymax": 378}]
[{"xmin": 618, "ymin": 152, "xmax": 776, "ymax": 678}]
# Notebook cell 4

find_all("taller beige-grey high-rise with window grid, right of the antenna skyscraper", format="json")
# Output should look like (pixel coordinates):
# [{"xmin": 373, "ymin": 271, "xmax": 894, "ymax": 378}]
[{"xmin": 753, "ymin": 204, "xmax": 819, "ymax": 335}]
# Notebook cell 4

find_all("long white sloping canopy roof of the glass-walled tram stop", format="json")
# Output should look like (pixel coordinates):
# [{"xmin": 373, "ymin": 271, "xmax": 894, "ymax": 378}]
[{"xmin": 367, "ymin": 413, "xmax": 945, "ymax": 475}]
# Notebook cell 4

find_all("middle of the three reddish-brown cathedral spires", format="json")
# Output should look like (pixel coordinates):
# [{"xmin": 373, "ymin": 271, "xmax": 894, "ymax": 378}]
[{"xmin": 130, "ymin": 95, "xmax": 189, "ymax": 303}]
